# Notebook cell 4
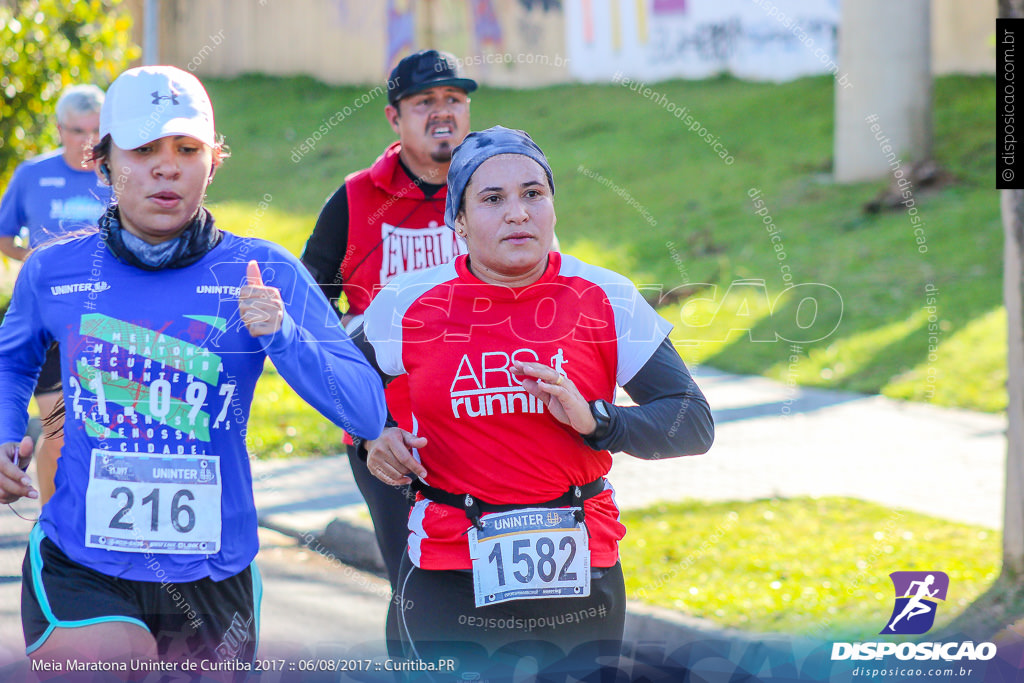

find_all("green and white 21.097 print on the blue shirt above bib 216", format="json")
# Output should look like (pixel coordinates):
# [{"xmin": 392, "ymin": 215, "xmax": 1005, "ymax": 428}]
[{"xmin": 69, "ymin": 313, "xmax": 236, "ymax": 447}]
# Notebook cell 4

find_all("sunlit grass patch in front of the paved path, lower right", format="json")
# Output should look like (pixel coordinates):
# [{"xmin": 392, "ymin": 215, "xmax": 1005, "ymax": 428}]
[{"xmin": 620, "ymin": 498, "xmax": 1001, "ymax": 640}]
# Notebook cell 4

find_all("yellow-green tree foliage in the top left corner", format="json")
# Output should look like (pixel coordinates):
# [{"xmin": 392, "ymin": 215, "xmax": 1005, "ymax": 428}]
[{"xmin": 0, "ymin": 0, "xmax": 139, "ymax": 187}]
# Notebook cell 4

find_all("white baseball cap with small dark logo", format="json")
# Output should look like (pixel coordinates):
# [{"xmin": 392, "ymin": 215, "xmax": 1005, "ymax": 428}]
[{"xmin": 99, "ymin": 67, "xmax": 216, "ymax": 150}]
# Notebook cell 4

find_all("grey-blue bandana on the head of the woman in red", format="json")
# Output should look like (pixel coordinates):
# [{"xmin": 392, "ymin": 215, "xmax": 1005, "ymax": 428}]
[{"xmin": 444, "ymin": 126, "xmax": 555, "ymax": 230}]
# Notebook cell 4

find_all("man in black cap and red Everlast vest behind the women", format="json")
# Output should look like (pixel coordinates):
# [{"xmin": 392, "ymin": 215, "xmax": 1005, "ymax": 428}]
[{"xmin": 302, "ymin": 50, "xmax": 476, "ymax": 589}]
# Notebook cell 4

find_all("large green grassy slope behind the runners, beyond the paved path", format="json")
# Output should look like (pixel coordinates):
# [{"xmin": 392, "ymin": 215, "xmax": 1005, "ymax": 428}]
[{"xmin": 0, "ymin": 76, "xmax": 991, "ymax": 455}]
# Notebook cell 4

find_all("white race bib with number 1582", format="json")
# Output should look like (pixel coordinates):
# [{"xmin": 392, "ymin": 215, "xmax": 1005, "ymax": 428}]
[{"xmin": 469, "ymin": 508, "xmax": 590, "ymax": 607}]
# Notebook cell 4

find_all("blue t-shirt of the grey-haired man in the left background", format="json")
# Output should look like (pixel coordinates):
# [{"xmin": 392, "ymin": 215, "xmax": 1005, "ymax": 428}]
[{"xmin": 0, "ymin": 147, "xmax": 111, "ymax": 247}]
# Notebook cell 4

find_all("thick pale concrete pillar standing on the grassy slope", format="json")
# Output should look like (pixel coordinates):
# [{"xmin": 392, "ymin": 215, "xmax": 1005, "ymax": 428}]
[{"xmin": 835, "ymin": 0, "xmax": 932, "ymax": 182}]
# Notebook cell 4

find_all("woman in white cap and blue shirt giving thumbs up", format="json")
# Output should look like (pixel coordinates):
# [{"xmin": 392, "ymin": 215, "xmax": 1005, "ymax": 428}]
[{"xmin": 0, "ymin": 67, "xmax": 385, "ymax": 663}]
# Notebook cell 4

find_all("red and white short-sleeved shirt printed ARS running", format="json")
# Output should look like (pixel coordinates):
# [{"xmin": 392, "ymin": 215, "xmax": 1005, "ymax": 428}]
[{"xmin": 365, "ymin": 252, "xmax": 672, "ymax": 569}]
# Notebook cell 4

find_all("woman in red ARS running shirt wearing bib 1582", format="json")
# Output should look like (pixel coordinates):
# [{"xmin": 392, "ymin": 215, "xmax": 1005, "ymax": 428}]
[{"xmin": 356, "ymin": 126, "xmax": 714, "ymax": 677}]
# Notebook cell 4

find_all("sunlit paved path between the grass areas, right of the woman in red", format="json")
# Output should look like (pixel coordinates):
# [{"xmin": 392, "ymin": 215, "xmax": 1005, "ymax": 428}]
[{"xmin": 609, "ymin": 368, "xmax": 1007, "ymax": 528}]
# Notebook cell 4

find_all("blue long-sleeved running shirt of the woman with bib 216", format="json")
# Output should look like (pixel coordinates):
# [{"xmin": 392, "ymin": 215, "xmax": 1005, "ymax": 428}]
[{"xmin": 0, "ymin": 233, "xmax": 386, "ymax": 582}]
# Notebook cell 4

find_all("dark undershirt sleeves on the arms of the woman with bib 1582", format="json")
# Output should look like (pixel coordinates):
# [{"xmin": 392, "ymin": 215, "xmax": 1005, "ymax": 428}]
[{"xmin": 352, "ymin": 325, "xmax": 715, "ymax": 460}]
